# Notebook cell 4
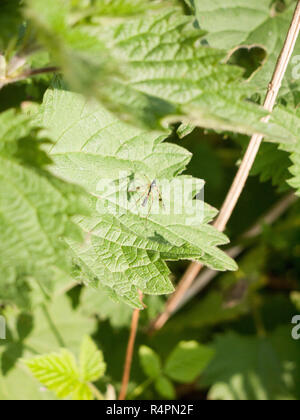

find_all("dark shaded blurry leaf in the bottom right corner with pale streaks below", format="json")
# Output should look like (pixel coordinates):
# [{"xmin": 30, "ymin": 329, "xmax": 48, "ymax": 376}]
[{"xmin": 203, "ymin": 327, "xmax": 300, "ymax": 401}]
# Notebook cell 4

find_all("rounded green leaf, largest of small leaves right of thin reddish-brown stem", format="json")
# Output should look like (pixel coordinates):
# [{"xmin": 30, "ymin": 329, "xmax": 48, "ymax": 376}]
[{"xmin": 164, "ymin": 341, "xmax": 214, "ymax": 383}]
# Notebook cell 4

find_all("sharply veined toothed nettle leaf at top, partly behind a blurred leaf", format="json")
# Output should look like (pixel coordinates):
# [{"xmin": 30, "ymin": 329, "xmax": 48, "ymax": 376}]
[{"xmin": 93, "ymin": 9, "xmax": 298, "ymax": 140}]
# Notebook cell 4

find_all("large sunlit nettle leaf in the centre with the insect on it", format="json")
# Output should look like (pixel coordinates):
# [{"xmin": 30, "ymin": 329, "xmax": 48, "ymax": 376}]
[{"xmin": 39, "ymin": 88, "xmax": 236, "ymax": 307}]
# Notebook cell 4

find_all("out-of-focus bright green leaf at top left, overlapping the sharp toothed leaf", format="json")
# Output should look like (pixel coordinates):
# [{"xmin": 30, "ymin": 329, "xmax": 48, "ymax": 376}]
[{"xmin": 23, "ymin": 0, "xmax": 172, "ymax": 99}]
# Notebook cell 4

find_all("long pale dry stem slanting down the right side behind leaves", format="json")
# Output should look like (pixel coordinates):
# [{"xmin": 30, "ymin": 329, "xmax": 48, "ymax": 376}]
[{"xmin": 152, "ymin": 0, "xmax": 300, "ymax": 330}]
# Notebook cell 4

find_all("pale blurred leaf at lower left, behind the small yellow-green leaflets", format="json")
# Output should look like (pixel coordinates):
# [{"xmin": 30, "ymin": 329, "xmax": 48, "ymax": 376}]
[{"xmin": 0, "ymin": 296, "xmax": 96, "ymax": 400}]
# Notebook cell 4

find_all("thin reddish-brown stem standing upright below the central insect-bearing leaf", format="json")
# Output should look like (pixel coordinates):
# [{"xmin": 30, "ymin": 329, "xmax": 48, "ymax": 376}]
[{"xmin": 119, "ymin": 292, "xmax": 142, "ymax": 401}]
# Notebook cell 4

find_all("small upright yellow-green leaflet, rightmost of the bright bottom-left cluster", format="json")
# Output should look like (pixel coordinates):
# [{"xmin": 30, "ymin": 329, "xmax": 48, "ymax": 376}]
[{"xmin": 80, "ymin": 335, "xmax": 106, "ymax": 382}]
